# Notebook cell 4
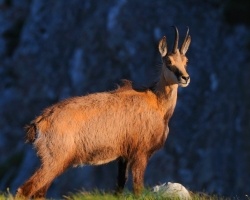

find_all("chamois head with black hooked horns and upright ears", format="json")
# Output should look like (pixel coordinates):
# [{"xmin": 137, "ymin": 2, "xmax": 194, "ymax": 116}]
[{"xmin": 159, "ymin": 26, "xmax": 191, "ymax": 87}]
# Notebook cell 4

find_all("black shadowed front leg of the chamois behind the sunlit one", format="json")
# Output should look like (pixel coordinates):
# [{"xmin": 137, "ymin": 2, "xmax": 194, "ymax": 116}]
[{"xmin": 115, "ymin": 158, "xmax": 128, "ymax": 195}]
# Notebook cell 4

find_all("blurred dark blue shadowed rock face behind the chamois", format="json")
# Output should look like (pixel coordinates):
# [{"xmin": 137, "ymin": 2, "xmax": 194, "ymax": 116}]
[{"xmin": 0, "ymin": 0, "xmax": 250, "ymax": 197}]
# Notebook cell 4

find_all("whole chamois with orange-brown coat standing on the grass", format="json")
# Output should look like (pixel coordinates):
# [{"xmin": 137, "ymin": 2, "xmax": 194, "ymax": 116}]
[{"xmin": 16, "ymin": 26, "xmax": 191, "ymax": 198}]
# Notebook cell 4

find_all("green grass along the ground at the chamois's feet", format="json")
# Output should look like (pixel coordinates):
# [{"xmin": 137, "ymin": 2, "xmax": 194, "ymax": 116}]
[{"xmin": 0, "ymin": 189, "xmax": 244, "ymax": 200}]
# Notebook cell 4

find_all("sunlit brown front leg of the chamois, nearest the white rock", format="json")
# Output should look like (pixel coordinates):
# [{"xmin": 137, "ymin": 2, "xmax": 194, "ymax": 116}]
[{"xmin": 131, "ymin": 155, "xmax": 148, "ymax": 195}]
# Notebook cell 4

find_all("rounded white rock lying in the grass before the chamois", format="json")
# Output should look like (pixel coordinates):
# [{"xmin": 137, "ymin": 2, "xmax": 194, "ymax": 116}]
[{"xmin": 153, "ymin": 182, "xmax": 191, "ymax": 199}]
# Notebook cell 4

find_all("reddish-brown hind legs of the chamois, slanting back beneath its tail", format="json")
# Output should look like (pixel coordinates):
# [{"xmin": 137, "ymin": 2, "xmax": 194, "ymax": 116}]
[{"xmin": 16, "ymin": 160, "xmax": 70, "ymax": 198}]
